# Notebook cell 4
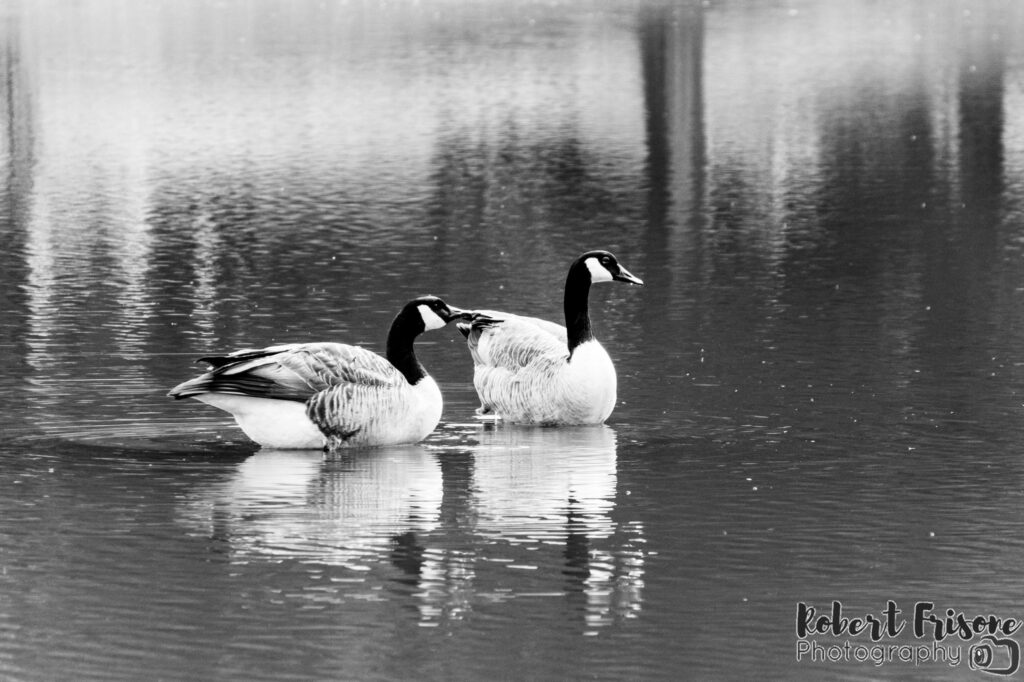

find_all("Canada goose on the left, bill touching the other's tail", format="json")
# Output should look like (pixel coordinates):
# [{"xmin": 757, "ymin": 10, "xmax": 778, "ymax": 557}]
[{"xmin": 168, "ymin": 296, "xmax": 473, "ymax": 450}]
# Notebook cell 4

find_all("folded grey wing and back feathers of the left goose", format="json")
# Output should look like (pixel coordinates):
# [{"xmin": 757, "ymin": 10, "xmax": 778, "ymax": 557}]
[{"xmin": 171, "ymin": 343, "xmax": 404, "ymax": 402}]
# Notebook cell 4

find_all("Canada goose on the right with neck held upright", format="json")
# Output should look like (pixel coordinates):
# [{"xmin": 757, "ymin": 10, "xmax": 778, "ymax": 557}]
[{"xmin": 458, "ymin": 246, "xmax": 643, "ymax": 424}]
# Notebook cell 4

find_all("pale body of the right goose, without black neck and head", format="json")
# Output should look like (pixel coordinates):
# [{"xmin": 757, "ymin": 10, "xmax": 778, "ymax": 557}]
[{"xmin": 470, "ymin": 311, "xmax": 616, "ymax": 425}]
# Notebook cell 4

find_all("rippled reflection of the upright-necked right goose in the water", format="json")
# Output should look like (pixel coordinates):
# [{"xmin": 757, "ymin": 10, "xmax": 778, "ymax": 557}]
[{"xmin": 462, "ymin": 425, "xmax": 646, "ymax": 626}]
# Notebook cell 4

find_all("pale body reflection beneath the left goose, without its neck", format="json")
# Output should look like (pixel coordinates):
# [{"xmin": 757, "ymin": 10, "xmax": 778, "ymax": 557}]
[{"xmin": 183, "ymin": 445, "xmax": 441, "ymax": 571}]
